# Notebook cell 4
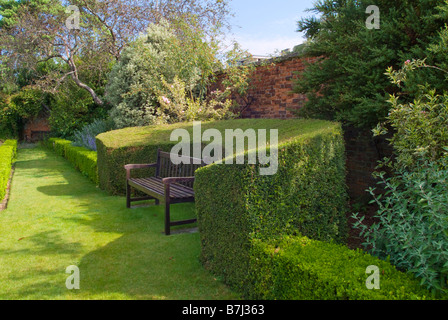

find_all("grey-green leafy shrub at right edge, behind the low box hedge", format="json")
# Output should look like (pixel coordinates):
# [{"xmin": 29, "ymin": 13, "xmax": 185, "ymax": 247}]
[{"xmin": 354, "ymin": 160, "xmax": 448, "ymax": 293}]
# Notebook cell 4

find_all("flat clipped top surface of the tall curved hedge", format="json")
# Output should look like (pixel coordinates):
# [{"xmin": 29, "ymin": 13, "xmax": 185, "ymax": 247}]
[{"xmin": 97, "ymin": 119, "xmax": 339, "ymax": 149}]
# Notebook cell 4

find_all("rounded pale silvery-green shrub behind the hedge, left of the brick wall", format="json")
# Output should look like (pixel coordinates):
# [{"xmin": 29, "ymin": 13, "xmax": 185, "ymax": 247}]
[{"xmin": 106, "ymin": 20, "xmax": 217, "ymax": 128}]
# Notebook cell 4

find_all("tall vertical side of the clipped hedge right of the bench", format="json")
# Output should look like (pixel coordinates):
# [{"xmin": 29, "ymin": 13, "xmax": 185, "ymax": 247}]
[{"xmin": 195, "ymin": 123, "xmax": 348, "ymax": 292}]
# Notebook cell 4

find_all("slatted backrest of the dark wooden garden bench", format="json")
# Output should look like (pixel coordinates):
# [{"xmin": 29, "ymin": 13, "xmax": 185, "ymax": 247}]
[{"xmin": 156, "ymin": 149, "xmax": 206, "ymax": 187}]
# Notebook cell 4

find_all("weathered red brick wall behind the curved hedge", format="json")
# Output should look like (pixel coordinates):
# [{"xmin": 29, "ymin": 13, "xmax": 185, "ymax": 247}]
[{"xmin": 213, "ymin": 55, "xmax": 392, "ymax": 201}]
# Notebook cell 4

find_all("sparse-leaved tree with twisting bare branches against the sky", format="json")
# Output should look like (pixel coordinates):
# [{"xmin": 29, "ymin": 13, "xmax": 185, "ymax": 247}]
[{"xmin": 0, "ymin": 0, "xmax": 229, "ymax": 105}]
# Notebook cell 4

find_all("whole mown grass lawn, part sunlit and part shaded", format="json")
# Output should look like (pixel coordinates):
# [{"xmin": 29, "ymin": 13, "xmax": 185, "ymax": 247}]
[{"xmin": 0, "ymin": 148, "xmax": 238, "ymax": 300}]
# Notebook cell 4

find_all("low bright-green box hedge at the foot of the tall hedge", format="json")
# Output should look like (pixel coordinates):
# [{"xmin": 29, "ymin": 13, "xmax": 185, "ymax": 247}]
[{"xmin": 245, "ymin": 237, "xmax": 440, "ymax": 300}]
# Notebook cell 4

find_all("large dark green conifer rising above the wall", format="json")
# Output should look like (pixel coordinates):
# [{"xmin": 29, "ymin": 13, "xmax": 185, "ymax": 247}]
[{"xmin": 295, "ymin": 0, "xmax": 448, "ymax": 128}]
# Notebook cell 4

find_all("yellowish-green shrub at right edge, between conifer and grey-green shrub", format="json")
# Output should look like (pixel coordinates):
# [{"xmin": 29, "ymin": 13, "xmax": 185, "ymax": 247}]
[{"xmin": 374, "ymin": 60, "xmax": 448, "ymax": 170}]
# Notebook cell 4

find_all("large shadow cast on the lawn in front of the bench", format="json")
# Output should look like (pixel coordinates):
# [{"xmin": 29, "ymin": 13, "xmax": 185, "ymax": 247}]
[{"xmin": 61, "ymin": 203, "xmax": 220, "ymax": 300}]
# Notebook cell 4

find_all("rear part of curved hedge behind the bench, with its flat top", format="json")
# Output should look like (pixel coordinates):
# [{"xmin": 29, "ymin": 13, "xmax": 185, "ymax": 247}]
[{"xmin": 96, "ymin": 119, "xmax": 332, "ymax": 195}]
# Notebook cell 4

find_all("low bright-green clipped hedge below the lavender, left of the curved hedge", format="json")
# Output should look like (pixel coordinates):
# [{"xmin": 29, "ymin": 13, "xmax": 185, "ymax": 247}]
[{"xmin": 43, "ymin": 138, "xmax": 98, "ymax": 184}]
